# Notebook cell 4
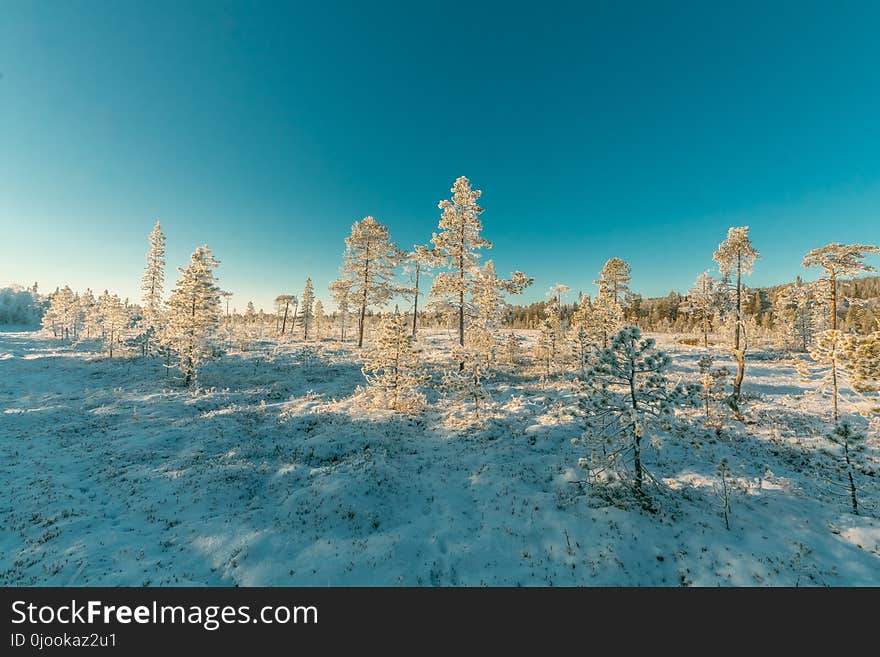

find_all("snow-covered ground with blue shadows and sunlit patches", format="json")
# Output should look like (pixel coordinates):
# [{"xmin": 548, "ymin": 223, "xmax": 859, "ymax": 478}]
[{"xmin": 0, "ymin": 332, "xmax": 880, "ymax": 586}]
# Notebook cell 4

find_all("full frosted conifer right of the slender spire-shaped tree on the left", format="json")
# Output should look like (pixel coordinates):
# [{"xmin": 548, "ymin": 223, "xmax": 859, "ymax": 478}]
[{"xmin": 163, "ymin": 245, "xmax": 222, "ymax": 385}]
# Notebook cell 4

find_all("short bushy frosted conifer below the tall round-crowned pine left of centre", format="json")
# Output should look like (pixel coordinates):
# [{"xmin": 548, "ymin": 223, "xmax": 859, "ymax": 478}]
[{"xmin": 361, "ymin": 313, "xmax": 428, "ymax": 413}]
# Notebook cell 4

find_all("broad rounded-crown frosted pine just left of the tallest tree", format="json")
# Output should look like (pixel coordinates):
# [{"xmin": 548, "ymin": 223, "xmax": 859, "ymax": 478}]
[{"xmin": 342, "ymin": 217, "xmax": 404, "ymax": 347}]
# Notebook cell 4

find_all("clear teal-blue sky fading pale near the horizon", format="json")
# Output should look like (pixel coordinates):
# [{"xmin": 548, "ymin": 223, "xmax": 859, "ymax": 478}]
[{"xmin": 0, "ymin": 0, "xmax": 880, "ymax": 309}]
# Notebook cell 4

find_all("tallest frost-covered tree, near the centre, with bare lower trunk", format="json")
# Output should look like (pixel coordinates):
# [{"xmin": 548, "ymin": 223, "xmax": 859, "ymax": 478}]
[{"xmin": 431, "ymin": 176, "xmax": 492, "ymax": 348}]
